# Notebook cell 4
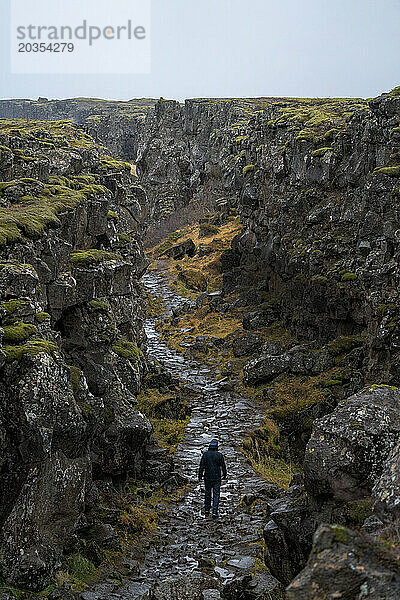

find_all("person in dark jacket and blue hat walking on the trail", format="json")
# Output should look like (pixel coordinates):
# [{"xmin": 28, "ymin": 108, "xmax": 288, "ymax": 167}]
[{"xmin": 199, "ymin": 440, "xmax": 226, "ymax": 518}]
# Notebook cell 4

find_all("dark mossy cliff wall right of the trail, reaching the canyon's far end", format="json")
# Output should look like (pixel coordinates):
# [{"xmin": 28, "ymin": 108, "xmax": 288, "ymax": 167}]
[{"xmin": 136, "ymin": 89, "xmax": 400, "ymax": 384}]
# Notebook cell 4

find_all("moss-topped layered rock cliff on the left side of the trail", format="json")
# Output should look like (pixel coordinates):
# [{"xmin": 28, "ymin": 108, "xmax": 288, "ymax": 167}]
[{"xmin": 0, "ymin": 120, "xmax": 150, "ymax": 589}]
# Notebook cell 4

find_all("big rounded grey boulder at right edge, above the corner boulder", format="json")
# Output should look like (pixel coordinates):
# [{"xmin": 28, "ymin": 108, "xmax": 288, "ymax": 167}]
[{"xmin": 304, "ymin": 386, "xmax": 400, "ymax": 500}]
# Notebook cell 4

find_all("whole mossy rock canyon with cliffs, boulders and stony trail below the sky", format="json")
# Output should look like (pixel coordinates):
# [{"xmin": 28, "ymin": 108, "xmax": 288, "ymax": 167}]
[{"xmin": 0, "ymin": 88, "xmax": 400, "ymax": 600}]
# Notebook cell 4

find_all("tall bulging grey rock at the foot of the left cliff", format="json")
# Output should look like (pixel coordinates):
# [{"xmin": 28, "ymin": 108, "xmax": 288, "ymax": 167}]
[{"xmin": 0, "ymin": 353, "xmax": 92, "ymax": 590}]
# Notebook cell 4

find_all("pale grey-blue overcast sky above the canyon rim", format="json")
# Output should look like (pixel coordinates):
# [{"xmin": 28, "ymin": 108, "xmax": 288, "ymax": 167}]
[{"xmin": 0, "ymin": 0, "xmax": 400, "ymax": 99}]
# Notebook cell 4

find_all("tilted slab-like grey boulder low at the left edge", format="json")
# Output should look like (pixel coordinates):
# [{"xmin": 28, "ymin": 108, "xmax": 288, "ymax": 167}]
[{"xmin": 0, "ymin": 452, "xmax": 91, "ymax": 591}]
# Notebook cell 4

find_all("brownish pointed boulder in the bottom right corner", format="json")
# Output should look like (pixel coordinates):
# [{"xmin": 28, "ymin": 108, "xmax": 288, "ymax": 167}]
[{"xmin": 286, "ymin": 525, "xmax": 400, "ymax": 600}]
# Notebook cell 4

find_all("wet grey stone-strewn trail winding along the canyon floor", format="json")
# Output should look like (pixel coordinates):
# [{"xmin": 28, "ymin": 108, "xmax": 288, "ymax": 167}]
[{"xmin": 82, "ymin": 273, "xmax": 277, "ymax": 600}]
